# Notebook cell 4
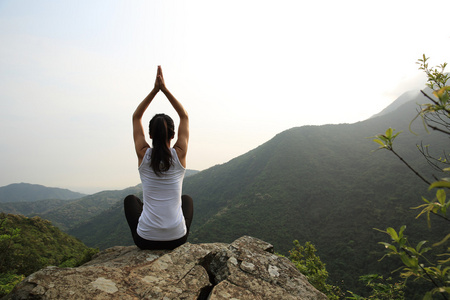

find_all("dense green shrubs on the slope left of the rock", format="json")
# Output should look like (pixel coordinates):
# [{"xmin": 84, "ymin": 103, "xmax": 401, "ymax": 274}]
[{"xmin": 0, "ymin": 213, "xmax": 98, "ymax": 293}]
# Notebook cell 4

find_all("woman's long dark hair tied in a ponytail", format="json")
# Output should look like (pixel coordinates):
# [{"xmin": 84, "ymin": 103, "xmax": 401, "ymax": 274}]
[{"xmin": 149, "ymin": 114, "xmax": 175, "ymax": 176}]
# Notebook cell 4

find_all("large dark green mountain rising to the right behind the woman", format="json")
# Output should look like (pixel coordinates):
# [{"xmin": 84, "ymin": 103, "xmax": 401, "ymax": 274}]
[{"xmin": 66, "ymin": 89, "xmax": 448, "ymax": 296}]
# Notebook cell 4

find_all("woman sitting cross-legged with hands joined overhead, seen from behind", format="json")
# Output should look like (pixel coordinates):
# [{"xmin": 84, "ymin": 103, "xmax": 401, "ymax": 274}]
[{"xmin": 124, "ymin": 66, "xmax": 194, "ymax": 249}]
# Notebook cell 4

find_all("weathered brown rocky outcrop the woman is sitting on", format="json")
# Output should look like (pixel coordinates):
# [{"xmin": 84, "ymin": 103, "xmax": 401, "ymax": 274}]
[{"xmin": 6, "ymin": 236, "xmax": 327, "ymax": 300}]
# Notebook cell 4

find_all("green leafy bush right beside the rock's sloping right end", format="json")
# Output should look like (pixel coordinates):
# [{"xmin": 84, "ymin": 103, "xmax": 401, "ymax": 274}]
[{"xmin": 289, "ymin": 240, "xmax": 342, "ymax": 299}]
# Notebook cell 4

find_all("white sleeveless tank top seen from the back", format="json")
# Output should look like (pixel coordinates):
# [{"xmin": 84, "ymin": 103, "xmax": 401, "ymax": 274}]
[{"xmin": 137, "ymin": 148, "xmax": 187, "ymax": 241}]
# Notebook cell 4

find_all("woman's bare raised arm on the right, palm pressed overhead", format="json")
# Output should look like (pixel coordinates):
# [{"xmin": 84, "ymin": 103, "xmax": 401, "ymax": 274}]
[{"xmin": 158, "ymin": 66, "xmax": 189, "ymax": 168}]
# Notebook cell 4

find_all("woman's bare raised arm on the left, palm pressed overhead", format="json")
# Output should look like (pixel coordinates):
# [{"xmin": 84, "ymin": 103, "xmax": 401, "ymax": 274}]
[{"xmin": 133, "ymin": 67, "xmax": 160, "ymax": 166}]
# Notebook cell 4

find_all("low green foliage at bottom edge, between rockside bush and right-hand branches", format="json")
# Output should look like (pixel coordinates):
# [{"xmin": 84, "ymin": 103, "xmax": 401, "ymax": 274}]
[{"xmin": 346, "ymin": 274, "xmax": 405, "ymax": 300}]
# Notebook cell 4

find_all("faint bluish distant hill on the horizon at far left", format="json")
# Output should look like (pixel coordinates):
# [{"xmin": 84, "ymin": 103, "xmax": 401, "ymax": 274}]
[{"xmin": 0, "ymin": 183, "xmax": 86, "ymax": 203}]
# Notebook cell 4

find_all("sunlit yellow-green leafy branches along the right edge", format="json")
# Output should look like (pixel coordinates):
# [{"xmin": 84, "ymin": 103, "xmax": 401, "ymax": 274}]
[{"xmin": 374, "ymin": 55, "xmax": 450, "ymax": 299}]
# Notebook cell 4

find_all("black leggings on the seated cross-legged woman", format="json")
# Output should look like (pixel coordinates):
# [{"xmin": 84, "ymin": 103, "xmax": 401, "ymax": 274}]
[{"xmin": 124, "ymin": 195, "xmax": 194, "ymax": 250}]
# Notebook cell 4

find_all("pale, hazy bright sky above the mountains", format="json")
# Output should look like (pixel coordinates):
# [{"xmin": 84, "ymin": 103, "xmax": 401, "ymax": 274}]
[{"xmin": 0, "ymin": 0, "xmax": 450, "ymax": 193}]
